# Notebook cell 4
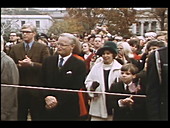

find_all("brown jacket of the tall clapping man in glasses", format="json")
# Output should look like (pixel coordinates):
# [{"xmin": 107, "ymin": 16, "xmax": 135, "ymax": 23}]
[{"xmin": 10, "ymin": 42, "xmax": 50, "ymax": 86}]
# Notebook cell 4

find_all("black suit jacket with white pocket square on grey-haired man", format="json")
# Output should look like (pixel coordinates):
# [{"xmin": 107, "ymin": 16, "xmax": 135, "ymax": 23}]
[{"xmin": 42, "ymin": 55, "xmax": 86, "ymax": 120}]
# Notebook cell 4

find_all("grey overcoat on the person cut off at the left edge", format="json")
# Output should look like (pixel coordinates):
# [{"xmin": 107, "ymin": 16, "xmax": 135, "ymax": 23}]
[{"xmin": 1, "ymin": 52, "xmax": 19, "ymax": 121}]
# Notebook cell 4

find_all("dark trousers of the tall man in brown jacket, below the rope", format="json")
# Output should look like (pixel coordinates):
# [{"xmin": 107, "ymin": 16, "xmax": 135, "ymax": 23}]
[{"xmin": 18, "ymin": 88, "xmax": 44, "ymax": 121}]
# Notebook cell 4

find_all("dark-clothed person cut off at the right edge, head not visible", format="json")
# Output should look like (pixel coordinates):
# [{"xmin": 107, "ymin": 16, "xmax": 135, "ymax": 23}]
[{"xmin": 146, "ymin": 47, "xmax": 168, "ymax": 121}]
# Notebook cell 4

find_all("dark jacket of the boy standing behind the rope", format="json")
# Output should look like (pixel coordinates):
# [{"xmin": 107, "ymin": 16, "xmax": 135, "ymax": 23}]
[{"xmin": 110, "ymin": 82, "xmax": 146, "ymax": 121}]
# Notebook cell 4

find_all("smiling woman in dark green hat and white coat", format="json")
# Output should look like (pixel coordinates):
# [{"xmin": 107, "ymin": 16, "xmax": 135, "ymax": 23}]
[{"xmin": 85, "ymin": 41, "xmax": 122, "ymax": 121}]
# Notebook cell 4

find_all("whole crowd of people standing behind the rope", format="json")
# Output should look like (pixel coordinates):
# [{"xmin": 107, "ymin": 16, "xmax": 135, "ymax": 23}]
[{"xmin": 1, "ymin": 23, "xmax": 168, "ymax": 121}]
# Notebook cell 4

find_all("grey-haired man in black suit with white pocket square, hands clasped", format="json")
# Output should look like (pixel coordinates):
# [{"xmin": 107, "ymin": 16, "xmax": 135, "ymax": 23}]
[{"xmin": 42, "ymin": 33, "xmax": 86, "ymax": 120}]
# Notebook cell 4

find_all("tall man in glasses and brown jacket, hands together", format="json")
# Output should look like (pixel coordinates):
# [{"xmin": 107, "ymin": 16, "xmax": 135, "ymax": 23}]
[{"xmin": 10, "ymin": 24, "xmax": 50, "ymax": 120}]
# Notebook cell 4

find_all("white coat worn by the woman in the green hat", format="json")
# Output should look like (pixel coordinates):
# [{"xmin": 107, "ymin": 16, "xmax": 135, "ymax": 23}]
[{"xmin": 85, "ymin": 60, "xmax": 122, "ymax": 118}]
